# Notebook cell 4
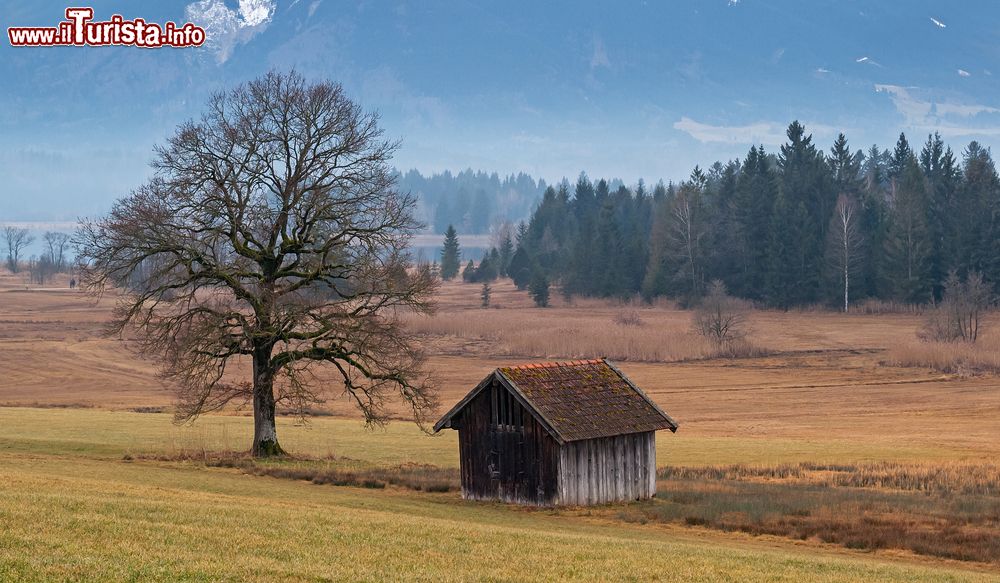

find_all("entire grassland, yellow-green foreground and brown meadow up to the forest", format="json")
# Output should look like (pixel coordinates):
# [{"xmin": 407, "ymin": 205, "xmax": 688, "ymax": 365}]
[{"xmin": 0, "ymin": 272, "xmax": 1000, "ymax": 581}]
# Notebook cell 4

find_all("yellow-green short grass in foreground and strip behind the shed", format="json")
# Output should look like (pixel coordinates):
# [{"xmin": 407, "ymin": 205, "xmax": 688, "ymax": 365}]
[{"xmin": 0, "ymin": 408, "xmax": 1000, "ymax": 581}]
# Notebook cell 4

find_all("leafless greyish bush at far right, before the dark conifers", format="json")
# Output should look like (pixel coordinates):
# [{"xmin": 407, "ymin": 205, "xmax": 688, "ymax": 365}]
[{"xmin": 918, "ymin": 271, "xmax": 993, "ymax": 342}]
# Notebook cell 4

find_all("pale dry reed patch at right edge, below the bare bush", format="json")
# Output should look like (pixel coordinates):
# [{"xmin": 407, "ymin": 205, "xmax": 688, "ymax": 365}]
[{"xmin": 885, "ymin": 330, "xmax": 1000, "ymax": 375}]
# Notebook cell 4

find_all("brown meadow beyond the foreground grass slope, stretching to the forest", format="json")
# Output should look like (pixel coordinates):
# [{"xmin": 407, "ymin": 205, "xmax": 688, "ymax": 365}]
[{"xmin": 0, "ymin": 274, "xmax": 1000, "ymax": 566}]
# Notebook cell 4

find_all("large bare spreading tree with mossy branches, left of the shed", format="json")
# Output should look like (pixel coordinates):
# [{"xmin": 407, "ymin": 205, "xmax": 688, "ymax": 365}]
[{"xmin": 76, "ymin": 72, "xmax": 436, "ymax": 456}]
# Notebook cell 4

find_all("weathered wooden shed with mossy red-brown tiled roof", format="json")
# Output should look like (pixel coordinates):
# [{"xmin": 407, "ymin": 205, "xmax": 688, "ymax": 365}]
[{"xmin": 434, "ymin": 359, "xmax": 677, "ymax": 505}]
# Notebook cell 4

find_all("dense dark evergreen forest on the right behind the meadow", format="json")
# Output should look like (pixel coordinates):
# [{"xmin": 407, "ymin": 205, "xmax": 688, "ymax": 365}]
[{"xmin": 498, "ymin": 122, "xmax": 1000, "ymax": 309}]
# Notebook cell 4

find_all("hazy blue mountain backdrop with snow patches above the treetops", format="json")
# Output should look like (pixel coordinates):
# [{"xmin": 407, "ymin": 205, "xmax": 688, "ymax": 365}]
[{"xmin": 0, "ymin": 0, "xmax": 1000, "ymax": 222}]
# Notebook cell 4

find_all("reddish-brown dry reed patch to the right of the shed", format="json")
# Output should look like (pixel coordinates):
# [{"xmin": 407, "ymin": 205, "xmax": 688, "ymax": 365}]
[{"xmin": 618, "ymin": 462, "xmax": 1000, "ymax": 564}]
